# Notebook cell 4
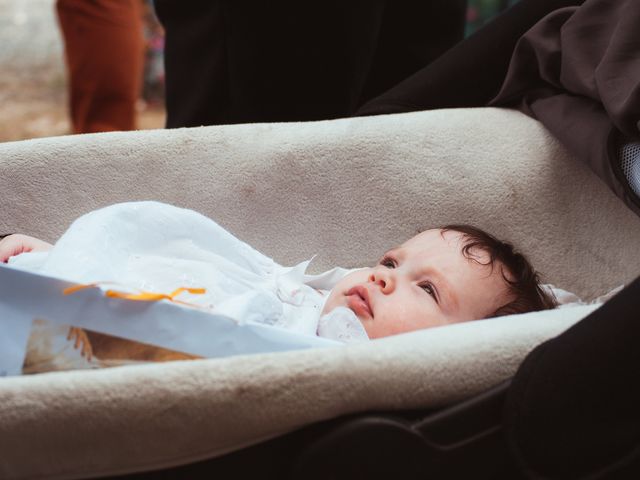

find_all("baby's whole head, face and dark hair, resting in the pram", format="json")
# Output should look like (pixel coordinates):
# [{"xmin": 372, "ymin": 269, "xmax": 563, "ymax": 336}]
[{"xmin": 324, "ymin": 225, "xmax": 556, "ymax": 338}]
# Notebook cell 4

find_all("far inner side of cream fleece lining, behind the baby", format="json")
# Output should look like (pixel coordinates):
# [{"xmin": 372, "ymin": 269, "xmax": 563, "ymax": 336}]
[{"xmin": 0, "ymin": 108, "xmax": 640, "ymax": 298}]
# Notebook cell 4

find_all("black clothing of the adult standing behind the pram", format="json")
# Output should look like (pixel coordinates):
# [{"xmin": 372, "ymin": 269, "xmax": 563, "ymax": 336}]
[{"xmin": 154, "ymin": 0, "xmax": 466, "ymax": 128}]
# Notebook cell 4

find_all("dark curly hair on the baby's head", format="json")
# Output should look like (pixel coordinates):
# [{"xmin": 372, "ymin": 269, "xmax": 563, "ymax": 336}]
[{"xmin": 441, "ymin": 224, "xmax": 558, "ymax": 317}]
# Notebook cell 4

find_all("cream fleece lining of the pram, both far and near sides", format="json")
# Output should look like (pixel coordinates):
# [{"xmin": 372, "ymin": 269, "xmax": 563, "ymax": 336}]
[{"xmin": 0, "ymin": 109, "xmax": 640, "ymax": 479}]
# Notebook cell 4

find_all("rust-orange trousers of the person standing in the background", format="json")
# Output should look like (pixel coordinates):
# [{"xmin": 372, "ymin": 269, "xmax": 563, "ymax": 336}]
[{"xmin": 56, "ymin": 0, "xmax": 144, "ymax": 133}]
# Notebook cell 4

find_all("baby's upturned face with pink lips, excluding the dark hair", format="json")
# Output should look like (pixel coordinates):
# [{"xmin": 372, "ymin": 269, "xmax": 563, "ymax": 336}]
[{"xmin": 323, "ymin": 229, "xmax": 510, "ymax": 338}]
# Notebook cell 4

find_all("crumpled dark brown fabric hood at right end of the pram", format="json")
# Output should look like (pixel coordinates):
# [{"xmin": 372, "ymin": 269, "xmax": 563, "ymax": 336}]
[{"xmin": 490, "ymin": 0, "xmax": 640, "ymax": 215}]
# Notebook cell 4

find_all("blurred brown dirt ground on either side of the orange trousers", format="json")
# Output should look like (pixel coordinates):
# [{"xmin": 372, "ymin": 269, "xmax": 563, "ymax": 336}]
[{"xmin": 0, "ymin": 67, "xmax": 165, "ymax": 142}]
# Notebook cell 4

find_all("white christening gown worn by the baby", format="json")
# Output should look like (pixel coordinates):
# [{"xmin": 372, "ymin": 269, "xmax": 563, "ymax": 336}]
[{"xmin": 10, "ymin": 202, "xmax": 368, "ymax": 343}]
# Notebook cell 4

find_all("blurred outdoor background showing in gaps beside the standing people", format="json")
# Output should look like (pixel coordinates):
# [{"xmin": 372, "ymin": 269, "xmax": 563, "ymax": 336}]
[{"xmin": 0, "ymin": 0, "xmax": 517, "ymax": 142}]
